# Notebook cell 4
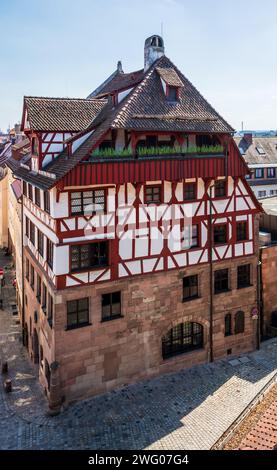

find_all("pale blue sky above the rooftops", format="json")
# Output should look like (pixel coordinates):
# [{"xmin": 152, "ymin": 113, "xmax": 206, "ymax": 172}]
[{"xmin": 0, "ymin": 0, "xmax": 277, "ymax": 130}]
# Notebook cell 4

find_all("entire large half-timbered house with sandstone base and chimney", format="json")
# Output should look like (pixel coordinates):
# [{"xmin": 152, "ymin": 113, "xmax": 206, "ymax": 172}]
[{"xmin": 9, "ymin": 36, "xmax": 261, "ymax": 409}]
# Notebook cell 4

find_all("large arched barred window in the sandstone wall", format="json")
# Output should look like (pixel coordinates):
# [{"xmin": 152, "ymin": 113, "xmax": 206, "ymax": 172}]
[{"xmin": 162, "ymin": 322, "xmax": 203, "ymax": 359}]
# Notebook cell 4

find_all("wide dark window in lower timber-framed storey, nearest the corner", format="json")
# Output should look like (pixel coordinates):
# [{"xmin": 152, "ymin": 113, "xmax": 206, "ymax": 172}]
[{"xmin": 71, "ymin": 242, "xmax": 108, "ymax": 271}]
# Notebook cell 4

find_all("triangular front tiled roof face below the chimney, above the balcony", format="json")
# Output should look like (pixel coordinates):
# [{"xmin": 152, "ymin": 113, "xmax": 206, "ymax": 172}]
[{"xmin": 110, "ymin": 56, "xmax": 234, "ymax": 133}]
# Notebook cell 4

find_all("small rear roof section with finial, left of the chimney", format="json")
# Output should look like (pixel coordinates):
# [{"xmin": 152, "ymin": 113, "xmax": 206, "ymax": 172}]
[{"xmin": 89, "ymin": 69, "xmax": 144, "ymax": 98}]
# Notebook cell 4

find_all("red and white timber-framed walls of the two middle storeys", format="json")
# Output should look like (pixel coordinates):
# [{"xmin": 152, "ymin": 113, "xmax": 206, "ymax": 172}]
[{"xmin": 24, "ymin": 176, "xmax": 260, "ymax": 289}]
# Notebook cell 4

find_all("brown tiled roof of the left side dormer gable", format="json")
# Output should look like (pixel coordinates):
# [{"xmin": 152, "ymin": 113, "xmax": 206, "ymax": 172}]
[{"xmin": 24, "ymin": 96, "xmax": 106, "ymax": 132}]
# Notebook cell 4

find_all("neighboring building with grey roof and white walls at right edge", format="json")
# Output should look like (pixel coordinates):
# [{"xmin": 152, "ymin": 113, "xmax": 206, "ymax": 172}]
[{"xmin": 235, "ymin": 134, "xmax": 277, "ymax": 199}]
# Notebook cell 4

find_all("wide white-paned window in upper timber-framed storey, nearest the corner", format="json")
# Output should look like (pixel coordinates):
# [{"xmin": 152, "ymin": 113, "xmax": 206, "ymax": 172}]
[{"xmin": 70, "ymin": 189, "xmax": 106, "ymax": 215}]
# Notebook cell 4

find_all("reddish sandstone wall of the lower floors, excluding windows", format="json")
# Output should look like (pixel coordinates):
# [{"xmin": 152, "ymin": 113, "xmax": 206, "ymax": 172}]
[{"xmin": 24, "ymin": 253, "xmax": 257, "ymax": 408}]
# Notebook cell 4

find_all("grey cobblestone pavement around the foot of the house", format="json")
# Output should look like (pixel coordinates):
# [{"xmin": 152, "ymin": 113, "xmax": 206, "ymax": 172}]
[{"xmin": 0, "ymin": 253, "xmax": 277, "ymax": 450}]
